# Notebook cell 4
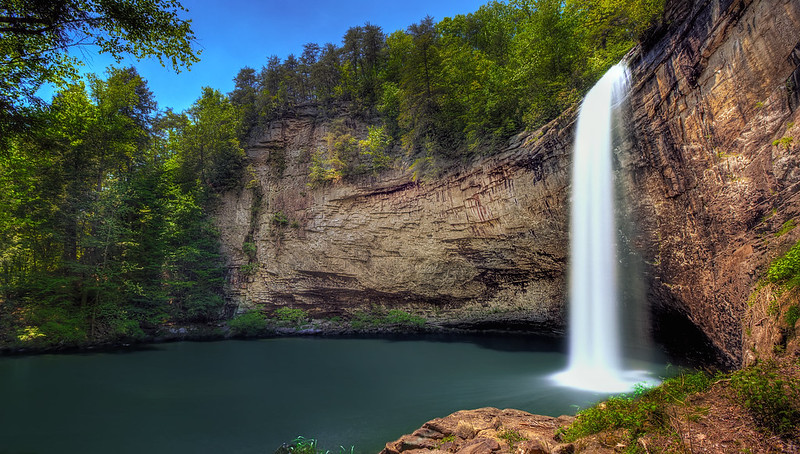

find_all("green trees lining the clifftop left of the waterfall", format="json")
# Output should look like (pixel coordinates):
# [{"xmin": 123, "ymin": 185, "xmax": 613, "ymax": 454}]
[{"xmin": 231, "ymin": 0, "xmax": 664, "ymax": 170}]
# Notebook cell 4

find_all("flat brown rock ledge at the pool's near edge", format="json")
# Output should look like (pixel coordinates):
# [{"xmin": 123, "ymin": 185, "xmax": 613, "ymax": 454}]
[{"xmin": 381, "ymin": 407, "xmax": 575, "ymax": 454}]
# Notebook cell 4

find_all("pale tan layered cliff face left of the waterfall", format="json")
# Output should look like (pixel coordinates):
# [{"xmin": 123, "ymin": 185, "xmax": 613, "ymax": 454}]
[{"xmin": 218, "ymin": 112, "xmax": 572, "ymax": 333}]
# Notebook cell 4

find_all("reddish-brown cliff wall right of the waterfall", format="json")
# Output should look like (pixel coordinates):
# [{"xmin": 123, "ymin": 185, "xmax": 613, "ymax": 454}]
[{"xmin": 618, "ymin": 0, "xmax": 800, "ymax": 364}]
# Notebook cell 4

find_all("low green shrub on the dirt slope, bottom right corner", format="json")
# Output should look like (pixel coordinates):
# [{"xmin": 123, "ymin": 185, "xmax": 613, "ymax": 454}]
[{"xmin": 731, "ymin": 362, "xmax": 800, "ymax": 436}]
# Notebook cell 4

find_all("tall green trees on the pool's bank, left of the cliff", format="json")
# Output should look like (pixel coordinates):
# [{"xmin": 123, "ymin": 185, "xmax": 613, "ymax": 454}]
[{"xmin": 0, "ymin": 68, "xmax": 230, "ymax": 344}]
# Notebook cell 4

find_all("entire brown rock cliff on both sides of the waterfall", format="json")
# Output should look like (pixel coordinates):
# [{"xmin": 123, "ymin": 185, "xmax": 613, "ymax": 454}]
[{"xmin": 217, "ymin": 0, "xmax": 800, "ymax": 365}]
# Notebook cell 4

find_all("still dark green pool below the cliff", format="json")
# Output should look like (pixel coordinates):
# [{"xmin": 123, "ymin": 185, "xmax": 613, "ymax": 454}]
[{"xmin": 0, "ymin": 337, "xmax": 658, "ymax": 454}]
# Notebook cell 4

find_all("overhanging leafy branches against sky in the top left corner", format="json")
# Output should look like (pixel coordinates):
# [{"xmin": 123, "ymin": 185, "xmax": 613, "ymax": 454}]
[{"xmin": 0, "ymin": 0, "xmax": 199, "ymax": 129}]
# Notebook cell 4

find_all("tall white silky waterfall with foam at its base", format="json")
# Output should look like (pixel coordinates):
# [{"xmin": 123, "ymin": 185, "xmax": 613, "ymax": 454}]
[{"xmin": 553, "ymin": 63, "xmax": 658, "ymax": 393}]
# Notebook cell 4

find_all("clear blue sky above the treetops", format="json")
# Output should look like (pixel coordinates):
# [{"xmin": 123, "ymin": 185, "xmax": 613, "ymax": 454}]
[{"xmin": 70, "ymin": 0, "xmax": 488, "ymax": 111}]
